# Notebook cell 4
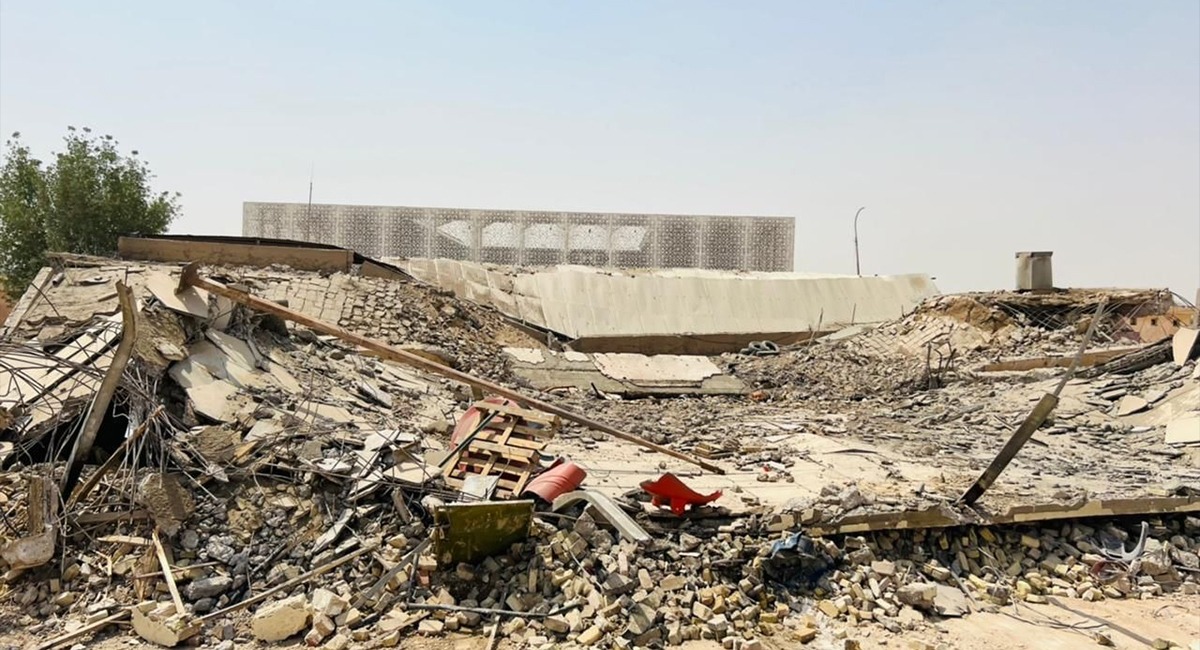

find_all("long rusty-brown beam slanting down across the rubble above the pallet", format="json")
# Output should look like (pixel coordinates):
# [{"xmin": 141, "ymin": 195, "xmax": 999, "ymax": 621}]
[{"xmin": 180, "ymin": 264, "xmax": 725, "ymax": 474}]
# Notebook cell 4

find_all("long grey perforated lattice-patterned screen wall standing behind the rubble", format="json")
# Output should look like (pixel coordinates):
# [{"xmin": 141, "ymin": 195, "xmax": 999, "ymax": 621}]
[{"xmin": 241, "ymin": 203, "xmax": 796, "ymax": 271}]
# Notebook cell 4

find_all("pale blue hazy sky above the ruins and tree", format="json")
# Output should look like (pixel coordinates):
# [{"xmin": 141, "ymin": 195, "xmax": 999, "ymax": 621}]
[{"xmin": 0, "ymin": 0, "xmax": 1200, "ymax": 300}]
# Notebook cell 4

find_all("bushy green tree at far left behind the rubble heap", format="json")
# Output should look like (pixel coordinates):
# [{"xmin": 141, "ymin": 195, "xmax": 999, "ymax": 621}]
[{"xmin": 0, "ymin": 127, "xmax": 180, "ymax": 296}]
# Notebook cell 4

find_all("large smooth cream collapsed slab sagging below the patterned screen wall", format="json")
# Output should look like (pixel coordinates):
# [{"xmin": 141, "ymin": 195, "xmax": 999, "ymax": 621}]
[{"xmin": 396, "ymin": 259, "xmax": 937, "ymax": 354}]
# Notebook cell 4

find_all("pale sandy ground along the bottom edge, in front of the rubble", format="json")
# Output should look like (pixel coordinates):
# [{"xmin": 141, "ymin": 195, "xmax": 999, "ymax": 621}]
[{"xmin": 7, "ymin": 596, "xmax": 1200, "ymax": 650}]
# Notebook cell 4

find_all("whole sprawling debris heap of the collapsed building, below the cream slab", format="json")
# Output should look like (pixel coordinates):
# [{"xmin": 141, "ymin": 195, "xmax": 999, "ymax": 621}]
[{"xmin": 0, "ymin": 239, "xmax": 1200, "ymax": 650}]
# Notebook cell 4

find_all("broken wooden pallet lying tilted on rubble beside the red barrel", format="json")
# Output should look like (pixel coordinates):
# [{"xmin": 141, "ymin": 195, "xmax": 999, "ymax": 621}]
[{"xmin": 442, "ymin": 402, "xmax": 560, "ymax": 499}]
